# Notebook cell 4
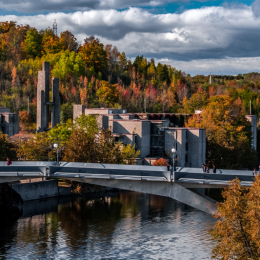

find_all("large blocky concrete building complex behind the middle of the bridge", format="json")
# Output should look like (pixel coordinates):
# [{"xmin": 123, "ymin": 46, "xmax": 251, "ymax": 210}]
[{"xmin": 73, "ymin": 105, "xmax": 206, "ymax": 167}]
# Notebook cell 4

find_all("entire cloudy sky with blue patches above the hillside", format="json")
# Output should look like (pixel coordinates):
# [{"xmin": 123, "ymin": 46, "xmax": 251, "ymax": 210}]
[{"xmin": 0, "ymin": 0, "xmax": 260, "ymax": 75}]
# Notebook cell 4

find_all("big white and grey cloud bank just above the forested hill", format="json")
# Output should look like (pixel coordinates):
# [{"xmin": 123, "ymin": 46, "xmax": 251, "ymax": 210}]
[{"xmin": 0, "ymin": 6, "xmax": 260, "ymax": 74}]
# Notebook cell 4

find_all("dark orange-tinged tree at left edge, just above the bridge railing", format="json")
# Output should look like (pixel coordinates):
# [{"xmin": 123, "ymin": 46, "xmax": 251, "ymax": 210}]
[{"xmin": 0, "ymin": 132, "xmax": 17, "ymax": 161}]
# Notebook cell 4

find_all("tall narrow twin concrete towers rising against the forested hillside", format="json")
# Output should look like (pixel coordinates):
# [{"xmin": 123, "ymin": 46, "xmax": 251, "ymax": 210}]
[{"xmin": 37, "ymin": 61, "xmax": 60, "ymax": 132}]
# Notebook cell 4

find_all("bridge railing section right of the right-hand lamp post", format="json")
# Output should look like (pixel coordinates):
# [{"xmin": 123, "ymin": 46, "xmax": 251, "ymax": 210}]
[{"xmin": 173, "ymin": 172, "xmax": 254, "ymax": 182}]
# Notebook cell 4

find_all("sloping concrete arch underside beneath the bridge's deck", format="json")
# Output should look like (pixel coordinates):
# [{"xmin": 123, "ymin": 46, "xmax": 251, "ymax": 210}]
[{"xmin": 60, "ymin": 177, "xmax": 217, "ymax": 215}]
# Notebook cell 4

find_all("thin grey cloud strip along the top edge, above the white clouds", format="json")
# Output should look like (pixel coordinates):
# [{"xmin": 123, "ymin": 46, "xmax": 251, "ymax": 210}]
[{"xmin": 0, "ymin": 0, "xmax": 208, "ymax": 13}]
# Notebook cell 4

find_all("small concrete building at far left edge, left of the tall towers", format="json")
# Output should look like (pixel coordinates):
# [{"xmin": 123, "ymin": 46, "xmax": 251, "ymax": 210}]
[{"xmin": 0, "ymin": 107, "xmax": 19, "ymax": 137}]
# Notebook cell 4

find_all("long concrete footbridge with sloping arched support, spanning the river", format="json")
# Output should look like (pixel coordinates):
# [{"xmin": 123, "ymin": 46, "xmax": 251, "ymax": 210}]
[{"xmin": 0, "ymin": 161, "xmax": 254, "ymax": 214}]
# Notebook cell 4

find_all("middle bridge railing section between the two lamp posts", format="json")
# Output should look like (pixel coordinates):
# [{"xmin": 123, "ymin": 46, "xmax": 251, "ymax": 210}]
[{"xmin": 49, "ymin": 166, "xmax": 170, "ymax": 181}]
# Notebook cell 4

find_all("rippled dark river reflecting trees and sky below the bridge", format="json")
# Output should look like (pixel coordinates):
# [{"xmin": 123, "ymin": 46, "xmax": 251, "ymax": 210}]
[{"xmin": 0, "ymin": 192, "xmax": 216, "ymax": 260}]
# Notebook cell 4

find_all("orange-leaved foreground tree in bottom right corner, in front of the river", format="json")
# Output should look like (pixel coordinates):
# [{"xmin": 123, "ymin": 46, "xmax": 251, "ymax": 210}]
[{"xmin": 211, "ymin": 174, "xmax": 260, "ymax": 260}]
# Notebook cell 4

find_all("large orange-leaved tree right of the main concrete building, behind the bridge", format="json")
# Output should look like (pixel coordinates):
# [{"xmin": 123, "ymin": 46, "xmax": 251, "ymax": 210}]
[{"xmin": 185, "ymin": 95, "xmax": 258, "ymax": 169}]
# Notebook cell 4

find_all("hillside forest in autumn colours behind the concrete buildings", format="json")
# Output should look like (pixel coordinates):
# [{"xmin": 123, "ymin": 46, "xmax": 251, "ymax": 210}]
[{"xmin": 0, "ymin": 21, "xmax": 260, "ymax": 168}]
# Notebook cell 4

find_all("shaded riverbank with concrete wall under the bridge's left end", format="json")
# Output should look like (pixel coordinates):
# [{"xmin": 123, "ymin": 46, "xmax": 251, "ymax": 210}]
[{"xmin": 0, "ymin": 178, "xmax": 118, "ymax": 223}]
